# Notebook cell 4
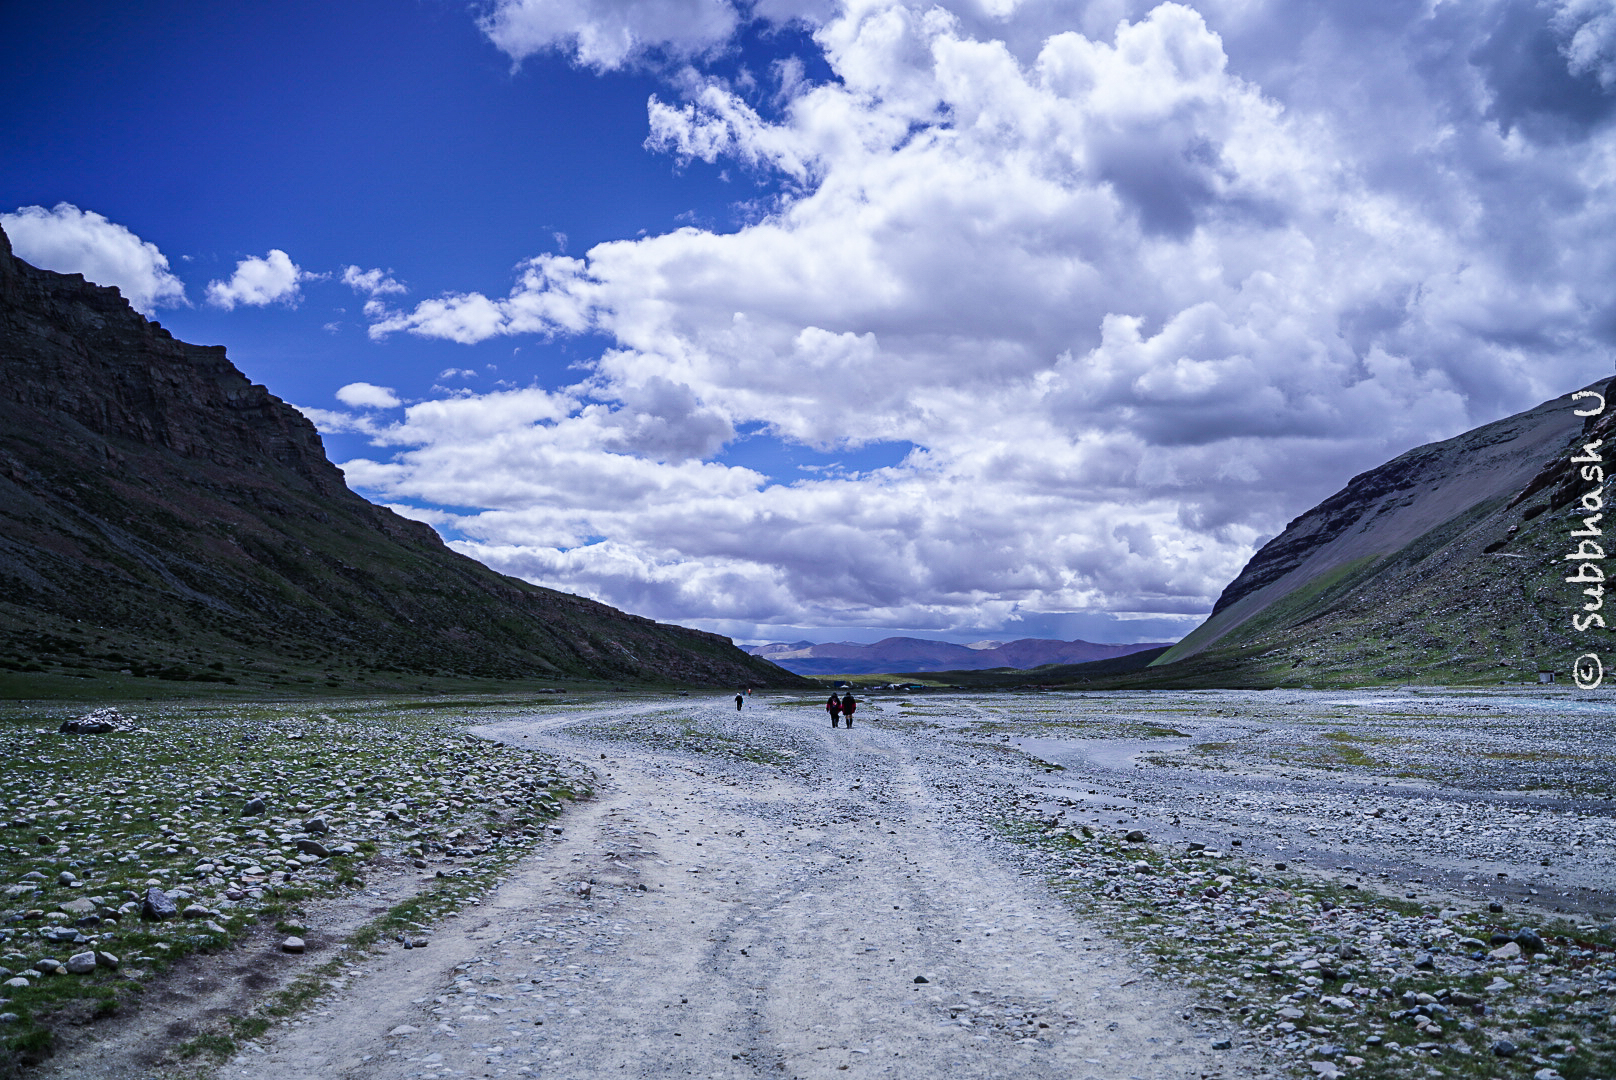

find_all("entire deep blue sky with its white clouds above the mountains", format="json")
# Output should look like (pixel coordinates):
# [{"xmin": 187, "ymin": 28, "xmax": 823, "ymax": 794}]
[{"xmin": 0, "ymin": 0, "xmax": 1616, "ymax": 642}]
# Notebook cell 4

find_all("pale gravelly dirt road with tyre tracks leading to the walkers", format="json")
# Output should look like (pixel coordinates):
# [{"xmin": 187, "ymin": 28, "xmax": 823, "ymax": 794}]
[{"xmin": 220, "ymin": 698, "xmax": 1265, "ymax": 1080}]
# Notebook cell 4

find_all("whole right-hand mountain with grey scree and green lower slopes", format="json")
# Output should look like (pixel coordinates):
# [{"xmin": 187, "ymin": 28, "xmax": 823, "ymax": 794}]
[{"xmin": 1149, "ymin": 375, "xmax": 1616, "ymax": 686}]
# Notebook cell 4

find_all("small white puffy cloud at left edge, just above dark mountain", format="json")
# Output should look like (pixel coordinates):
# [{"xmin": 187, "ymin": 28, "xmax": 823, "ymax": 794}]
[{"xmin": 0, "ymin": 202, "xmax": 186, "ymax": 314}]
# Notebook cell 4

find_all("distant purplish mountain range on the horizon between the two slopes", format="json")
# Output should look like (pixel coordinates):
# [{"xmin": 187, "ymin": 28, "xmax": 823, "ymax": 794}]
[{"xmin": 747, "ymin": 637, "xmax": 1170, "ymax": 676}]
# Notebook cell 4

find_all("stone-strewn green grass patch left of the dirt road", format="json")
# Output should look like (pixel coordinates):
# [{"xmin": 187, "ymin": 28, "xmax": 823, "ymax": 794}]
[{"xmin": 0, "ymin": 700, "xmax": 588, "ymax": 1075}]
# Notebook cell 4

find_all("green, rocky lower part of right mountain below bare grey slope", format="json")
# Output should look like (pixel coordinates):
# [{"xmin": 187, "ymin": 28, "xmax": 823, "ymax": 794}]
[{"xmin": 1117, "ymin": 398, "xmax": 1616, "ymax": 687}]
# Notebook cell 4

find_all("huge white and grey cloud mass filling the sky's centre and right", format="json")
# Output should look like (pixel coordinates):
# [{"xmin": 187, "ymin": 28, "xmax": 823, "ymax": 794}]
[{"xmin": 334, "ymin": 0, "xmax": 1616, "ymax": 629}]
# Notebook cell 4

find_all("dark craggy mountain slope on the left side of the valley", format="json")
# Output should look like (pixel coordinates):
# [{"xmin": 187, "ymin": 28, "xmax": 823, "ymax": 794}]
[{"xmin": 0, "ymin": 233, "xmax": 803, "ymax": 695}]
